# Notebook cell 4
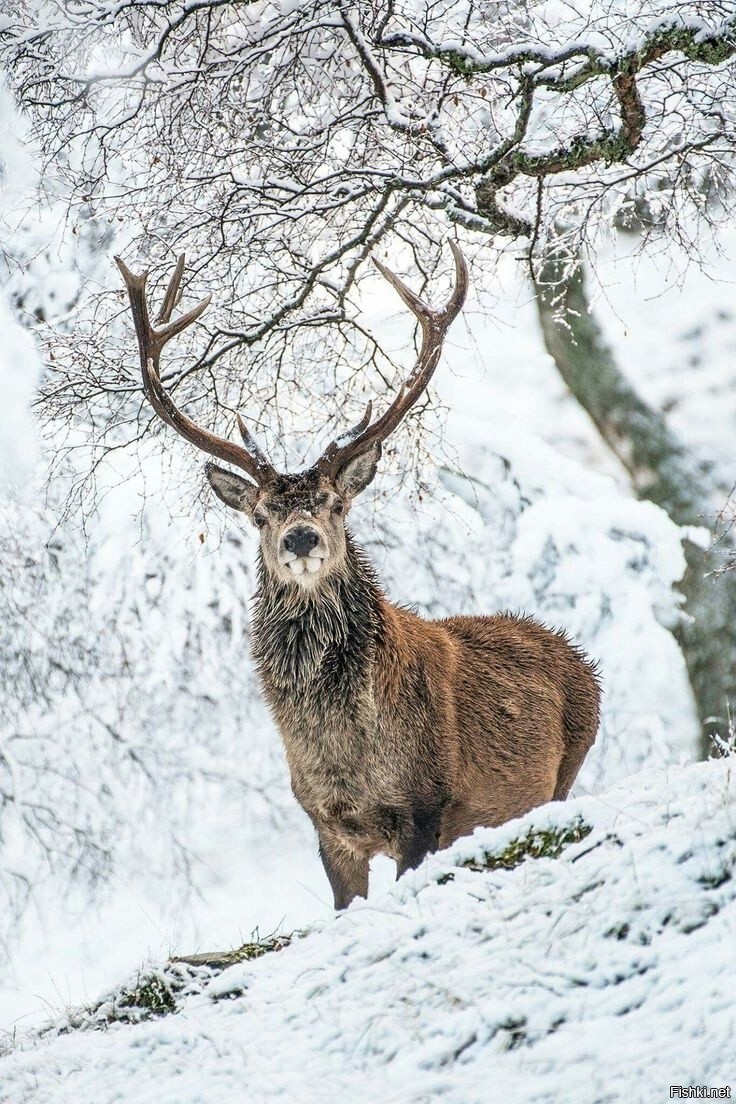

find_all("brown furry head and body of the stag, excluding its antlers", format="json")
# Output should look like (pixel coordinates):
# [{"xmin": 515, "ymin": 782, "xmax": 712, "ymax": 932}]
[{"xmin": 204, "ymin": 467, "xmax": 599, "ymax": 909}]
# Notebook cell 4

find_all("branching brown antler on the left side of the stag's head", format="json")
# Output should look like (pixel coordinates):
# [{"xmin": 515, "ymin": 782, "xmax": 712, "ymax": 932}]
[{"xmin": 115, "ymin": 253, "xmax": 276, "ymax": 486}]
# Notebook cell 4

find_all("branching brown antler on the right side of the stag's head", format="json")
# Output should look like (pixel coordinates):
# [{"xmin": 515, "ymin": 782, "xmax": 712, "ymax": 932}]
[{"xmin": 318, "ymin": 242, "xmax": 469, "ymax": 474}]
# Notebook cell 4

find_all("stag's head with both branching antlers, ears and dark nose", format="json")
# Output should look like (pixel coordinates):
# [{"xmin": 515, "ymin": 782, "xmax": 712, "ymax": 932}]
[{"xmin": 115, "ymin": 242, "xmax": 468, "ymax": 587}]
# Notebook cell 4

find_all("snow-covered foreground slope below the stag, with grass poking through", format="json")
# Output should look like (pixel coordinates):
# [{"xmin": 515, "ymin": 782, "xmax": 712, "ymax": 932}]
[{"xmin": 0, "ymin": 758, "xmax": 736, "ymax": 1104}]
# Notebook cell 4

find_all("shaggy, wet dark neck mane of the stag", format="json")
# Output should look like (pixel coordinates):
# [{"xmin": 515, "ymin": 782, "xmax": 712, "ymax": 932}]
[{"xmin": 253, "ymin": 535, "xmax": 384, "ymax": 702}]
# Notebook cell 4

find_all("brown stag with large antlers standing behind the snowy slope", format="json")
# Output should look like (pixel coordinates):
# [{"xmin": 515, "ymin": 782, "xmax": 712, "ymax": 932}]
[{"xmin": 116, "ymin": 242, "xmax": 600, "ymax": 911}]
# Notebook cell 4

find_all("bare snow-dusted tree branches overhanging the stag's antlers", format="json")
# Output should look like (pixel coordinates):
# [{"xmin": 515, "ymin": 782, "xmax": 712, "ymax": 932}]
[{"xmin": 1, "ymin": 0, "xmax": 736, "ymax": 750}]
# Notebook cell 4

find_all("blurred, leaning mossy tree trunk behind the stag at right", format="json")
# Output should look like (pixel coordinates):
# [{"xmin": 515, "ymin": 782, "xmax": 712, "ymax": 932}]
[{"xmin": 535, "ymin": 254, "xmax": 736, "ymax": 757}]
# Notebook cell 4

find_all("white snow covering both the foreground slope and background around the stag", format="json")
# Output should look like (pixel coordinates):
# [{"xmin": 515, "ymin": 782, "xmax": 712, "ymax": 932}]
[{"xmin": 0, "ymin": 8, "xmax": 736, "ymax": 1104}]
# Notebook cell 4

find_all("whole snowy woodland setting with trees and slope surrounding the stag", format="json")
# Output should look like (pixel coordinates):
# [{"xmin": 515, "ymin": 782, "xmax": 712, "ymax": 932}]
[{"xmin": 0, "ymin": 0, "xmax": 736, "ymax": 1104}]
